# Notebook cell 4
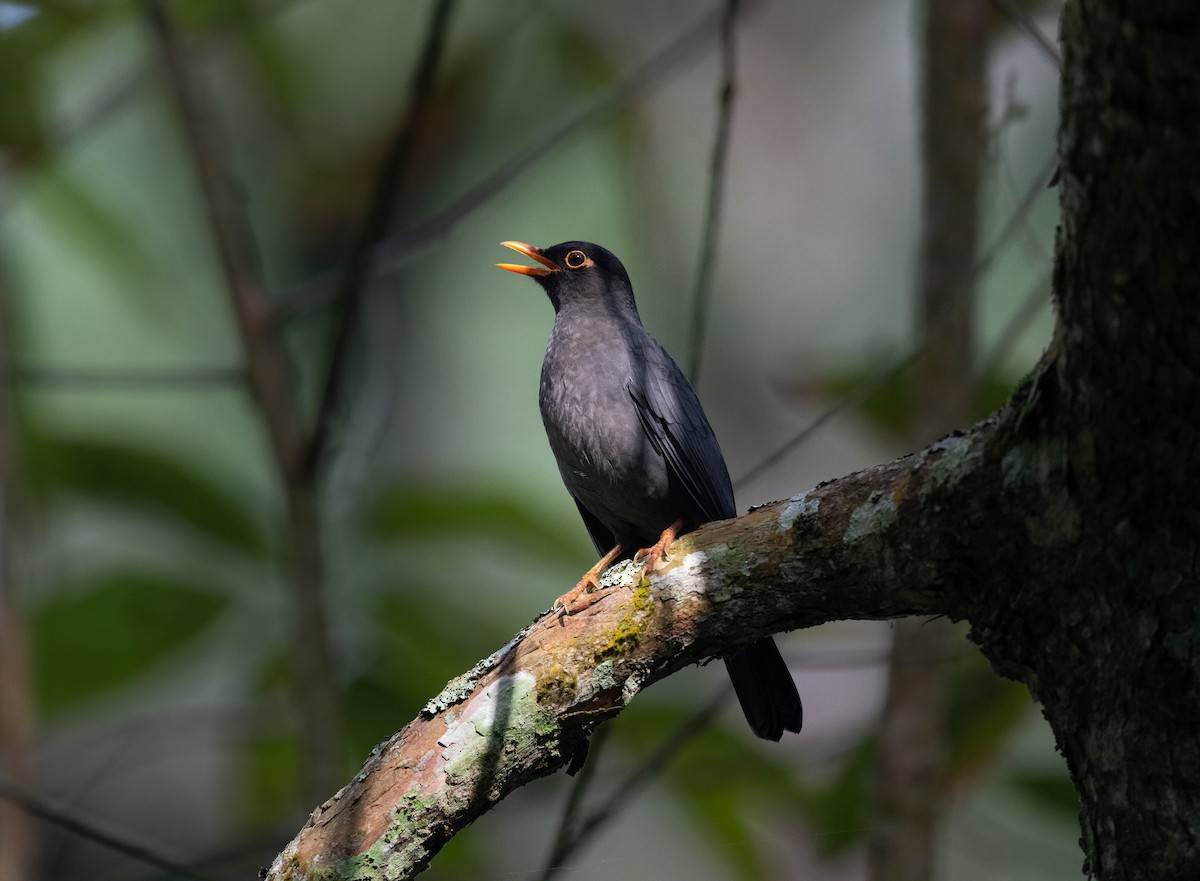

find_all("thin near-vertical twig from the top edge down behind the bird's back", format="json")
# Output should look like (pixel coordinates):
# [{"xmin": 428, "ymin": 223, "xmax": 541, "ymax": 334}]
[{"xmin": 688, "ymin": 0, "xmax": 742, "ymax": 385}]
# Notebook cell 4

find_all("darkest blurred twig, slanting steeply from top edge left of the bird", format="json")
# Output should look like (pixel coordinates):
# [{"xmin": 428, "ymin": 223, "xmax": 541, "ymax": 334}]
[{"xmin": 304, "ymin": 0, "xmax": 455, "ymax": 472}]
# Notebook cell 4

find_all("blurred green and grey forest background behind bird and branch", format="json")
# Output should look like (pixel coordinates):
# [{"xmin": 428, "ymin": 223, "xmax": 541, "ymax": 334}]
[{"xmin": 0, "ymin": 0, "xmax": 1081, "ymax": 881}]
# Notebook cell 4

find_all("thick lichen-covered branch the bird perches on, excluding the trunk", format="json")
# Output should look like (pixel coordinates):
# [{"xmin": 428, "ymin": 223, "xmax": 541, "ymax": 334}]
[{"xmin": 270, "ymin": 408, "xmax": 1036, "ymax": 881}]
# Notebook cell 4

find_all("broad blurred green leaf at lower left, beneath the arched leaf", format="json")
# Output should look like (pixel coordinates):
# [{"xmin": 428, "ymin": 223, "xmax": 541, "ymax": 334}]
[{"xmin": 32, "ymin": 571, "xmax": 227, "ymax": 714}]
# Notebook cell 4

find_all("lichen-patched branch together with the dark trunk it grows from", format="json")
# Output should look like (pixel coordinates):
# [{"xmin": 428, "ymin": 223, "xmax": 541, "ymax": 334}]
[{"xmin": 270, "ymin": 0, "xmax": 1200, "ymax": 881}]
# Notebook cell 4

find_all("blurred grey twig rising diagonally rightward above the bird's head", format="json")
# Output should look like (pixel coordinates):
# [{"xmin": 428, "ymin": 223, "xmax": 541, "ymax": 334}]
[{"xmin": 275, "ymin": 5, "xmax": 722, "ymax": 320}]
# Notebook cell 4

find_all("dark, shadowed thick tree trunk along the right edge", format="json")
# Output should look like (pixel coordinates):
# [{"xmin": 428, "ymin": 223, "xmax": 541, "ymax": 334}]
[{"xmin": 1012, "ymin": 1, "xmax": 1200, "ymax": 880}]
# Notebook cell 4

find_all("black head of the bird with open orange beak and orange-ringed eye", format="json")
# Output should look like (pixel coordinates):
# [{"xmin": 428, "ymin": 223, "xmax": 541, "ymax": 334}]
[{"xmin": 496, "ymin": 241, "xmax": 637, "ymax": 316}]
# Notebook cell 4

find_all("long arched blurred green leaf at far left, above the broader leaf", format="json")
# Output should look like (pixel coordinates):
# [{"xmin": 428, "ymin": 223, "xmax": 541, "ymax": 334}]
[{"xmin": 24, "ymin": 434, "xmax": 268, "ymax": 556}]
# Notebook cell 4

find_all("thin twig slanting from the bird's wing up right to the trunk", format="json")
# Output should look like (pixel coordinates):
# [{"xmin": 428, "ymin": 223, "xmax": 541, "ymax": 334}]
[{"xmin": 733, "ymin": 151, "xmax": 1057, "ymax": 489}]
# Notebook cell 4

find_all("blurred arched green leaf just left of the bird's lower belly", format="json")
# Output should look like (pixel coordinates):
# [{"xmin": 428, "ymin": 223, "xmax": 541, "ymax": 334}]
[{"xmin": 368, "ymin": 484, "xmax": 584, "ymax": 565}]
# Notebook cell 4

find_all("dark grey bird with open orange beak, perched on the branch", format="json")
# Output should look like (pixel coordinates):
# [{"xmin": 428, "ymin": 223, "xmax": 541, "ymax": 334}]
[{"xmin": 496, "ymin": 241, "xmax": 804, "ymax": 741}]
